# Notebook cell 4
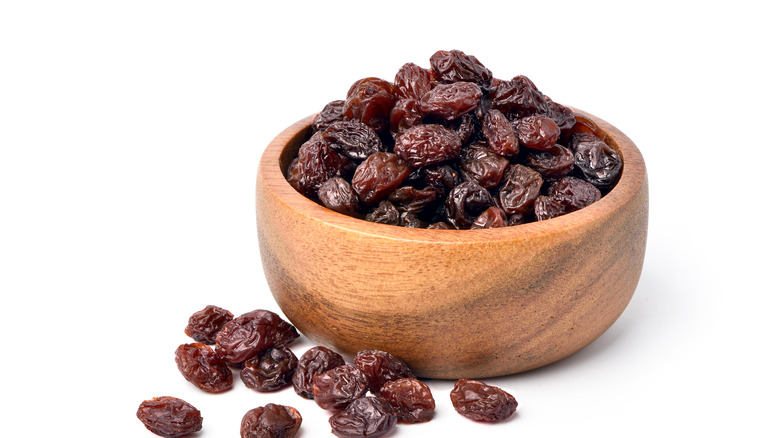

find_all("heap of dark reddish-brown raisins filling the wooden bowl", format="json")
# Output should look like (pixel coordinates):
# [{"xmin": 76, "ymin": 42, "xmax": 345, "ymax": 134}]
[{"xmin": 286, "ymin": 50, "xmax": 622, "ymax": 229}]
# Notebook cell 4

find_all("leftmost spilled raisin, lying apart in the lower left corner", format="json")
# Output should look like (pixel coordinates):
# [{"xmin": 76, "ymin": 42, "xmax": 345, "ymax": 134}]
[{"xmin": 136, "ymin": 396, "xmax": 203, "ymax": 438}]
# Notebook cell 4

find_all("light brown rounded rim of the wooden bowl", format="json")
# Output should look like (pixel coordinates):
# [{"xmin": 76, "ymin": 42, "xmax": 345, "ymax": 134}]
[{"xmin": 256, "ymin": 107, "xmax": 647, "ymax": 244}]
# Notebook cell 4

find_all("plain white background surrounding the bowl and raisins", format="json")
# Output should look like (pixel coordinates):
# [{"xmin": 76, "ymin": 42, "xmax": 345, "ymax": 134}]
[{"xmin": 0, "ymin": 0, "xmax": 780, "ymax": 438}]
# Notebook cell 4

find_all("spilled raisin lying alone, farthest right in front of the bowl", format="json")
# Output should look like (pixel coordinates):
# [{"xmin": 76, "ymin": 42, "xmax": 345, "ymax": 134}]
[{"xmin": 450, "ymin": 379, "xmax": 517, "ymax": 423}]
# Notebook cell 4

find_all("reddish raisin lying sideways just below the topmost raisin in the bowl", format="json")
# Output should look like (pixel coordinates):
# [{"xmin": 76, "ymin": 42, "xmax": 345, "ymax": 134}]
[{"xmin": 420, "ymin": 82, "xmax": 482, "ymax": 120}]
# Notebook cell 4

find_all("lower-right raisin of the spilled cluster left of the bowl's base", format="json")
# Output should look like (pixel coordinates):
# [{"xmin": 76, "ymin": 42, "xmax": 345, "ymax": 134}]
[{"xmin": 240, "ymin": 347, "xmax": 298, "ymax": 392}]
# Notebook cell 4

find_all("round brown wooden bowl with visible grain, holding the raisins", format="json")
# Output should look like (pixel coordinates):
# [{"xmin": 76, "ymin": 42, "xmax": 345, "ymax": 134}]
[{"xmin": 257, "ymin": 110, "xmax": 648, "ymax": 379}]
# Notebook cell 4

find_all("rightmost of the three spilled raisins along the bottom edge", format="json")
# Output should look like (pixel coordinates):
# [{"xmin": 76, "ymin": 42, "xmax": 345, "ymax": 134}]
[{"xmin": 328, "ymin": 397, "xmax": 398, "ymax": 438}]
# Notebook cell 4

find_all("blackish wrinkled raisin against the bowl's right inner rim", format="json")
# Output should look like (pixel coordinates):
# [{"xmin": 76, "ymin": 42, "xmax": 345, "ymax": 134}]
[{"xmin": 570, "ymin": 134, "xmax": 623, "ymax": 190}]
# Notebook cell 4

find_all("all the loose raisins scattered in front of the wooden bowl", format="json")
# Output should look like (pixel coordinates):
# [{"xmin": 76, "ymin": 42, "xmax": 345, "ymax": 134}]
[{"xmin": 136, "ymin": 306, "xmax": 517, "ymax": 438}]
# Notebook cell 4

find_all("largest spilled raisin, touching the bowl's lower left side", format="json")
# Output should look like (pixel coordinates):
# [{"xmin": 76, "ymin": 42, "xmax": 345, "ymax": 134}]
[{"xmin": 216, "ymin": 309, "xmax": 299, "ymax": 363}]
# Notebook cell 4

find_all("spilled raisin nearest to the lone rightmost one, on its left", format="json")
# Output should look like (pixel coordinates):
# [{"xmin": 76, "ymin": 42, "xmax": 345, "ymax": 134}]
[{"xmin": 379, "ymin": 377, "xmax": 436, "ymax": 423}]
